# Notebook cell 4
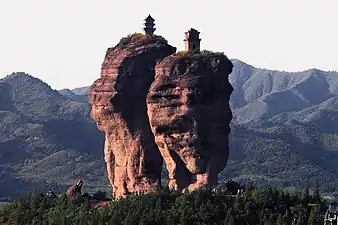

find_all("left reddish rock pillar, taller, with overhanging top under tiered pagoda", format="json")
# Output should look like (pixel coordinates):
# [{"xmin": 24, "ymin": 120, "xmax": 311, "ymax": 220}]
[{"xmin": 89, "ymin": 34, "xmax": 176, "ymax": 198}]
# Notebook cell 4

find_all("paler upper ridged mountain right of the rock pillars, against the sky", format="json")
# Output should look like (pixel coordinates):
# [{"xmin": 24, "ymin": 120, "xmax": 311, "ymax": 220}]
[{"xmin": 230, "ymin": 60, "xmax": 338, "ymax": 124}]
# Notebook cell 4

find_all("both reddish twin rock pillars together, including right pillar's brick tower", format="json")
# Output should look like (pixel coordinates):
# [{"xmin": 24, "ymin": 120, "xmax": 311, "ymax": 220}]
[{"xmin": 89, "ymin": 21, "xmax": 233, "ymax": 198}]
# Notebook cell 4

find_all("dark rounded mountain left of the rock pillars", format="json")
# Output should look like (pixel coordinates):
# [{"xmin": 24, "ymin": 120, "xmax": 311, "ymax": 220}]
[{"xmin": 0, "ymin": 73, "xmax": 105, "ymax": 197}]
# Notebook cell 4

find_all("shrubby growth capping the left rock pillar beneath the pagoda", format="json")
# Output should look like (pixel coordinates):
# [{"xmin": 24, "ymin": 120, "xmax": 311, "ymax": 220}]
[{"xmin": 115, "ymin": 33, "xmax": 168, "ymax": 49}]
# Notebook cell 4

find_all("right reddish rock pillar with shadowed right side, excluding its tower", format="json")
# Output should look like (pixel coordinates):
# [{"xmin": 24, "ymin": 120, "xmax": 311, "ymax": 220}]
[{"xmin": 147, "ymin": 52, "xmax": 233, "ymax": 191}]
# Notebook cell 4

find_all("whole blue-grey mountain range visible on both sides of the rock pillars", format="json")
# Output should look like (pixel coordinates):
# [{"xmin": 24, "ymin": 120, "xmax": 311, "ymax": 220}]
[{"xmin": 0, "ymin": 60, "xmax": 338, "ymax": 198}]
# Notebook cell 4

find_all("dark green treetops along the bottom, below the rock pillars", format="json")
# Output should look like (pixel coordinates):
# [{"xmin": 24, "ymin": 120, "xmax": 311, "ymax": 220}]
[{"xmin": 0, "ymin": 188, "xmax": 326, "ymax": 225}]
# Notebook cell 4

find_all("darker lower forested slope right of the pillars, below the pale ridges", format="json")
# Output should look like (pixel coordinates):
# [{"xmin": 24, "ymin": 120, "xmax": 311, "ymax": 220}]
[{"xmin": 220, "ymin": 126, "xmax": 338, "ymax": 192}]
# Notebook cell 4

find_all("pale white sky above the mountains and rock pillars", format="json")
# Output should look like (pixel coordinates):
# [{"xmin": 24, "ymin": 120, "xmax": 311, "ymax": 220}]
[{"xmin": 0, "ymin": 0, "xmax": 338, "ymax": 89}]
